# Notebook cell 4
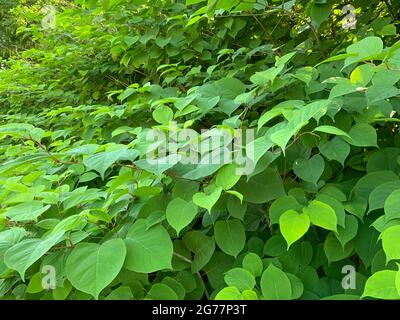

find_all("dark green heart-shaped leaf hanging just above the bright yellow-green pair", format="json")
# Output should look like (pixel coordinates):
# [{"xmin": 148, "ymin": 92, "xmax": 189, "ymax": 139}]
[{"xmin": 293, "ymin": 154, "xmax": 325, "ymax": 184}]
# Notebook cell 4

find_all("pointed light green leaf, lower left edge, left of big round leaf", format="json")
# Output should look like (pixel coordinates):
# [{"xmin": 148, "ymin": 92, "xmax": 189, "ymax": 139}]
[{"xmin": 4, "ymin": 233, "xmax": 64, "ymax": 279}]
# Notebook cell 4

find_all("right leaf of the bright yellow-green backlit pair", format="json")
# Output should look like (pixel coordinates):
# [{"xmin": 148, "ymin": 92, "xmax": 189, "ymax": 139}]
[{"xmin": 303, "ymin": 200, "xmax": 337, "ymax": 232}]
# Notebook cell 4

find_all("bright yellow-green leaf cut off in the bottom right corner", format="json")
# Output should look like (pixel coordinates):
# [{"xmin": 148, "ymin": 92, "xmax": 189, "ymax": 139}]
[{"xmin": 362, "ymin": 270, "xmax": 400, "ymax": 300}]
